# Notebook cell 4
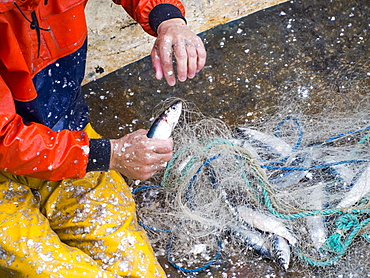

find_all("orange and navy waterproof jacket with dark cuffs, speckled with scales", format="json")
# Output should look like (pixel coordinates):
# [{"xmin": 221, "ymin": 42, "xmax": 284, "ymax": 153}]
[{"xmin": 0, "ymin": 0, "xmax": 184, "ymax": 180}]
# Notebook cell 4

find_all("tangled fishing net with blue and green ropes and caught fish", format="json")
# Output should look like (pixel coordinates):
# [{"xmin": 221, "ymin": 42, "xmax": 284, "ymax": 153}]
[{"xmin": 134, "ymin": 91, "xmax": 370, "ymax": 272}]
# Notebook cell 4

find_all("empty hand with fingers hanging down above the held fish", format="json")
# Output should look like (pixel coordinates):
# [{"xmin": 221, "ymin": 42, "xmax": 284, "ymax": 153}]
[{"xmin": 151, "ymin": 18, "xmax": 207, "ymax": 86}]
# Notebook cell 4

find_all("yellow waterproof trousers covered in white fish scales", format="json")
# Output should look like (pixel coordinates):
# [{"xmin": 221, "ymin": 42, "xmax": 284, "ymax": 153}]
[{"xmin": 0, "ymin": 125, "xmax": 165, "ymax": 278}]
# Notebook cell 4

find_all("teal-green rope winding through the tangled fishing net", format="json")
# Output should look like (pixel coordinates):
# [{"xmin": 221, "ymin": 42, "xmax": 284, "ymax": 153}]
[{"xmin": 161, "ymin": 138, "xmax": 370, "ymax": 266}]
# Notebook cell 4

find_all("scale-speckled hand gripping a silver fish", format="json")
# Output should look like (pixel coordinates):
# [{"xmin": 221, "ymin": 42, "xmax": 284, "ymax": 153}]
[{"xmin": 109, "ymin": 129, "xmax": 173, "ymax": 180}]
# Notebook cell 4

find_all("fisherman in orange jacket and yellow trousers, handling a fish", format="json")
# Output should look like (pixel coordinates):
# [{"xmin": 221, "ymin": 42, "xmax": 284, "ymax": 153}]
[{"xmin": 0, "ymin": 0, "xmax": 206, "ymax": 278}]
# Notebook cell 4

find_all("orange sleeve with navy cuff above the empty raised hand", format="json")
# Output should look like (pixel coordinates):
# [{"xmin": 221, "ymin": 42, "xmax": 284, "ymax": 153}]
[{"xmin": 113, "ymin": 0, "xmax": 185, "ymax": 36}]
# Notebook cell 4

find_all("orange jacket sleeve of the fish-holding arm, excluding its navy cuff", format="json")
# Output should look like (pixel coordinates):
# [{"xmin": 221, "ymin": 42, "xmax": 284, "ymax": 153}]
[{"xmin": 0, "ymin": 76, "xmax": 89, "ymax": 180}]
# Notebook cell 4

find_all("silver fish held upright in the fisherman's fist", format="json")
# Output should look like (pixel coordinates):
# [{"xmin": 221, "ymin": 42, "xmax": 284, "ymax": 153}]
[{"xmin": 147, "ymin": 100, "xmax": 182, "ymax": 140}]
